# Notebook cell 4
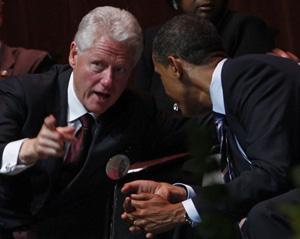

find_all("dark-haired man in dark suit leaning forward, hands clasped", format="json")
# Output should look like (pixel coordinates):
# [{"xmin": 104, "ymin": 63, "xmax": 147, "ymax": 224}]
[{"xmin": 122, "ymin": 15, "xmax": 300, "ymax": 238}]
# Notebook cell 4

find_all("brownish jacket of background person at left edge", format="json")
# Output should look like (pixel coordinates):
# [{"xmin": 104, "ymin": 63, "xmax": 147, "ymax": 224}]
[{"xmin": 0, "ymin": 42, "xmax": 53, "ymax": 76}]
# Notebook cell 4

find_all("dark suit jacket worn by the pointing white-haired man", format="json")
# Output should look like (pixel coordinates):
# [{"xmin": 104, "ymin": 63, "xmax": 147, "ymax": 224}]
[{"xmin": 0, "ymin": 66, "xmax": 188, "ymax": 238}]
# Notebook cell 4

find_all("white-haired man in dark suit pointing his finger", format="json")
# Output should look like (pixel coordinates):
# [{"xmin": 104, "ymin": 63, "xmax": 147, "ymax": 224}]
[{"xmin": 0, "ymin": 7, "xmax": 188, "ymax": 238}]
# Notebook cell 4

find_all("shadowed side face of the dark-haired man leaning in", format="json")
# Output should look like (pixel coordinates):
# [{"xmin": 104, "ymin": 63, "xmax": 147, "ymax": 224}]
[{"xmin": 153, "ymin": 59, "xmax": 211, "ymax": 116}]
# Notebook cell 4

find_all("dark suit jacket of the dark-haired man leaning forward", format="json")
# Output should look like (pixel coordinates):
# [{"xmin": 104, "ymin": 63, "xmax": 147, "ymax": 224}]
[{"xmin": 193, "ymin": 55, "xmax": 300, "ymax": 222}]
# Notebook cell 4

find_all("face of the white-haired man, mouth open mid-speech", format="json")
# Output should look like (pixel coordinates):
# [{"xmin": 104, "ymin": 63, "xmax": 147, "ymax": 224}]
[{"xmin": 69, "ymin": 37, "xmax": 134, "ymax": 115}]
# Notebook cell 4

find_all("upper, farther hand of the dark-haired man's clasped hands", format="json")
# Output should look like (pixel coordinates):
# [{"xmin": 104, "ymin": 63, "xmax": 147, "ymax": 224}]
[{"xmin": 121, "ymin": 180, "xmax": 186, "ymax": 203}]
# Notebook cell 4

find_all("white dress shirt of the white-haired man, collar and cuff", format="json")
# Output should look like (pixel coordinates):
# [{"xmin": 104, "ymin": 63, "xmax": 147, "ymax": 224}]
[{"xmin": 0, "ymin": 73, "xmax": 90, "ymax": 175}]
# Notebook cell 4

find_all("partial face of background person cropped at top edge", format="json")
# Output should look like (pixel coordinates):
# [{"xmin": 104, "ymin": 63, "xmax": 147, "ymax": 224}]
[{"xmin": 180, "ymin": 0, "xmax": 228, "ymax": 20}]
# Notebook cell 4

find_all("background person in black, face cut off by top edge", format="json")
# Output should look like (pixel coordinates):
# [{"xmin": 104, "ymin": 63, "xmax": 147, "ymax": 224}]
[{"xmin": 135, "ymin": 0, "xmax": 276, "ymax": 113}]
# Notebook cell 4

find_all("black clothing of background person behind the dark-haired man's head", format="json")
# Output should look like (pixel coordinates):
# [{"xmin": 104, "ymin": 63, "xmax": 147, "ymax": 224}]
[{"xmin": 135, "ymin": 11, "xmax": 275, "ymax": 112}]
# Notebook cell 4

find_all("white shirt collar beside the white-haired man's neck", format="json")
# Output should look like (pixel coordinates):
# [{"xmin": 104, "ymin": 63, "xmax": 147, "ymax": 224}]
[{"xmin": 67, "ymin": 72, "xmax": 88, "ymax": 123}]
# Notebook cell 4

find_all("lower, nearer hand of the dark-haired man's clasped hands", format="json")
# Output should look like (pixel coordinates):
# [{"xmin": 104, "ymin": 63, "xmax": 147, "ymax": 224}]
[{"xmin": 121, "ymin": 193, "xmax": 185, "ymax": 238}]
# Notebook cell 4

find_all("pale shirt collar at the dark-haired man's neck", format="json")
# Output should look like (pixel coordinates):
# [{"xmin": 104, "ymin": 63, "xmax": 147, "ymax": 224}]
[{"xmin": 209, "ymin": 58, "xmax": 227, "ymax": 115}]
